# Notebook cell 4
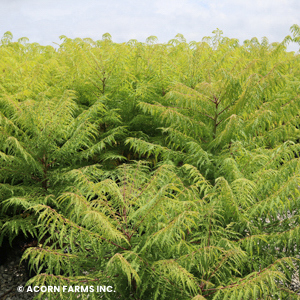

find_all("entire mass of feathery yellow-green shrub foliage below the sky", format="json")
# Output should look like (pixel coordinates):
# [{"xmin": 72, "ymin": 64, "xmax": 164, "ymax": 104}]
[{"xmin": 0, "ymin": 25, "xmax": 300, "ymax": 300}]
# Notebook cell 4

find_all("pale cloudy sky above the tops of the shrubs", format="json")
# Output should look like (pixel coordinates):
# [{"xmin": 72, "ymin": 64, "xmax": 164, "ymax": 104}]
[{"xmin": 0, "ymin": 0, "xmax": 300, "ymax": 51}]
